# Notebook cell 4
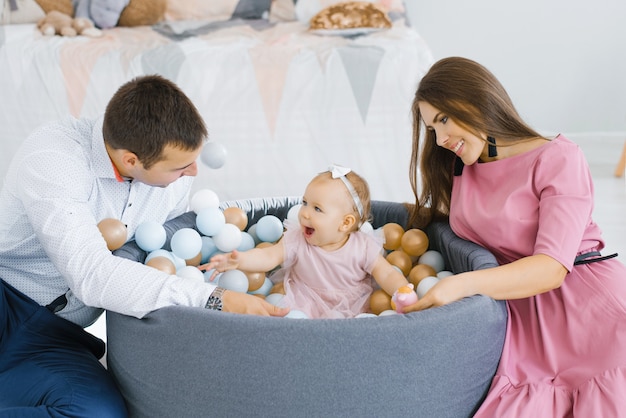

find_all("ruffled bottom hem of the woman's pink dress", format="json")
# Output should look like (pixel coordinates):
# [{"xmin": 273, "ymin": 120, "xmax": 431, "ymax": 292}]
[{"xmin": 474, "ymin": 366, "xmax": 626, "ymax": 418}]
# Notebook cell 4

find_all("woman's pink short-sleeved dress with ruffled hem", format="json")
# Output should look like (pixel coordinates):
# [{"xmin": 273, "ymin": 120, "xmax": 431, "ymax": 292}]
[{"xmin": 450, "ymin": 135, "xmax": 626, "ymax": 418}]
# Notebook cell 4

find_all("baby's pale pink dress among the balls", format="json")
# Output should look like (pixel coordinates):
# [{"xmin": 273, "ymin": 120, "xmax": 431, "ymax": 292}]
[{"xmin": 270, "ymin": 224, "xmax": 382, "ymax": 318}]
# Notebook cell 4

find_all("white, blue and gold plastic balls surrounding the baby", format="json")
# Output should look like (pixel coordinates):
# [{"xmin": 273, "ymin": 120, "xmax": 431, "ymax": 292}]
[{"xmin": 98, "ymin": 189, "xmax": 452, "ymax": 317}]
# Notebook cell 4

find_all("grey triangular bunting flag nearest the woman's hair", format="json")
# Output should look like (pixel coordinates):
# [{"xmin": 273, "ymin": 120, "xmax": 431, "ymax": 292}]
[{"xmin": 337, "ymin": 45, "xmax": 385, "ymax": 123}]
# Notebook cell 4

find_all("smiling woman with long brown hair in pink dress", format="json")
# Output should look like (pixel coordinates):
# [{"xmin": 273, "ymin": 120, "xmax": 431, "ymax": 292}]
[{"xmin": 406, "ymin": 57, "xmax": 626, "ymax": 418}]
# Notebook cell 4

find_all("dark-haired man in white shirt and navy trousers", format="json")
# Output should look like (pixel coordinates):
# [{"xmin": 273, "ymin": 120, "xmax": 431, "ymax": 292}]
[{"xmin": 0, "ymin": 76, "xmax": 287, "ymax": 417}]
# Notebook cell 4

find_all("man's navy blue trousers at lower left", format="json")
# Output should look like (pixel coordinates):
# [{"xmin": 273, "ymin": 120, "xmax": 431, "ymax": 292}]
[{"xmin": 0, "ymin": 280, "xmax": 127, "ymax": 418}]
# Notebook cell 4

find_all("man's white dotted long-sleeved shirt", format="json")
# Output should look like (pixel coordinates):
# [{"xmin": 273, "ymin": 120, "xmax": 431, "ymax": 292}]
[{"xmin": 0, "ymin": 118, "xmax": 215, "ymax": 327}]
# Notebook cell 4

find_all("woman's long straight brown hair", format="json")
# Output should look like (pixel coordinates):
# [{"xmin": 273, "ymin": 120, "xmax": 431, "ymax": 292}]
[{"xmin": 409, "ymin": 57, "xmax": 541, "ymax": 228}]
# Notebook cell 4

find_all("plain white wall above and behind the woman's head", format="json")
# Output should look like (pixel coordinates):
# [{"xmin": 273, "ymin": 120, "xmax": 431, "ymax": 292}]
[{"xmin": 405, "ymin": 0, "xmax": 626, "ymax": 136}]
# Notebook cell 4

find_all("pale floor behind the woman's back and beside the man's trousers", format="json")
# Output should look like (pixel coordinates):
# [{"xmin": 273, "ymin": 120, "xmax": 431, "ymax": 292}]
[{"xmin": 89, "ymin": 137, "xmax": 626, "ymax": 339}]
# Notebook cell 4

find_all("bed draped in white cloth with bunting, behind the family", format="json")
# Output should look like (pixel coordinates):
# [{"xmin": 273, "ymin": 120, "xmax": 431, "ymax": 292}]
[{"xmin": 0, "ymin": 0, "xmax": 433, "ymax": 201}]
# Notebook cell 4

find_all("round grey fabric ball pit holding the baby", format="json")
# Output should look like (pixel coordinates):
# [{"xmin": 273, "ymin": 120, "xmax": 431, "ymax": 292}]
[{"xmin": 107, "ymin": 198, "xmax": 507, "ymax": 418}]
